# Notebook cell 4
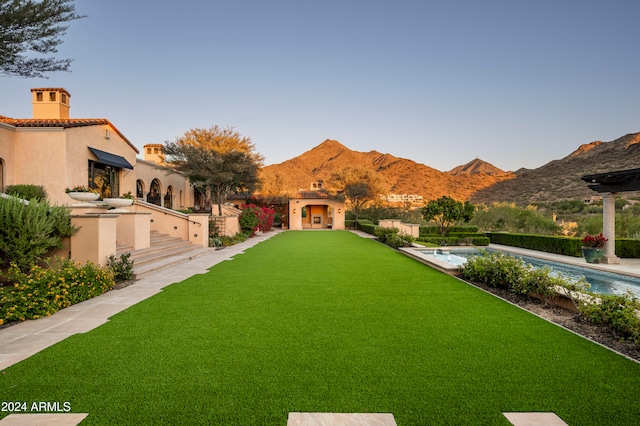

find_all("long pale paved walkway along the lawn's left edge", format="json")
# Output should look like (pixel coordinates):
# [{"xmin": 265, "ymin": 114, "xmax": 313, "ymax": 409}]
[{"xmin": 0, "ymin": 230, "xmax": 282, "ymax": 371}]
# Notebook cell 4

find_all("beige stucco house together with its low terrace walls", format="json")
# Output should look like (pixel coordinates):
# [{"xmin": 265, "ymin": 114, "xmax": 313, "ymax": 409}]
[{"xmin": 0, "ymin": 88, "xmax": 210, "ymax": 265}]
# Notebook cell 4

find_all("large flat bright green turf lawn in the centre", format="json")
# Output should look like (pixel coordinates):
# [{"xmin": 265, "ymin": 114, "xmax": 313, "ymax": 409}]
[{"xmin": 0, "ymin": 231, "xmax": 640, "ymax": 426}]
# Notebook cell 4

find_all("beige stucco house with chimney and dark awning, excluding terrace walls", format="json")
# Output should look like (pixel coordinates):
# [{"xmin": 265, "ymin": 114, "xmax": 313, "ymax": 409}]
[{"xmin": 0, "ymin": 88, "xmax": 194, "ymax": 209}]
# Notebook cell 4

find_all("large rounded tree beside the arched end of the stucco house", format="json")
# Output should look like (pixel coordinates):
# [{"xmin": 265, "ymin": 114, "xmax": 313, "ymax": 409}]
[{"xmin": 165, "ymin": 126, "xmax": 262, "ymax": 216}]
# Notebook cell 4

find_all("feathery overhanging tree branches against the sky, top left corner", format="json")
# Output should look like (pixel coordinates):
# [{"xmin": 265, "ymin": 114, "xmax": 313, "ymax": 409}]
[{"xmin": 0, "ymin": 0, "xmax": 84, "ymax": 78}]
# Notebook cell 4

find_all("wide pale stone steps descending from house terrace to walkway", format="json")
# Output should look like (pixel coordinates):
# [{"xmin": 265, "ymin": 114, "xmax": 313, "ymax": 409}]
[{"xmin": 116, "ymin": 231, "xmax": 214, "ymax": 278}]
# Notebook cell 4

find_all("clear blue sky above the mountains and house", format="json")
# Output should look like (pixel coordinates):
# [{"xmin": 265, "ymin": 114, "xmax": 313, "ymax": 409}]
[{"xmin": 0, "ymin": 0, "xmax": 640, "ymax": 171}]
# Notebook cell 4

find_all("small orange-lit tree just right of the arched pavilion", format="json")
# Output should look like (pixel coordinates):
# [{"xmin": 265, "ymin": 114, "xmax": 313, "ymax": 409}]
[{"xmin": 330, "ymin": 167, "xmax": 387, "ymax": 220}]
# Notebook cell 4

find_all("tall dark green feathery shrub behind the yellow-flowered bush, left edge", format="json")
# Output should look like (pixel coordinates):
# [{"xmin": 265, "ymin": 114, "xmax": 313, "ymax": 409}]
[{"xmin": 0, "ymin": 198, "xmax": 78, "ymax": 271}]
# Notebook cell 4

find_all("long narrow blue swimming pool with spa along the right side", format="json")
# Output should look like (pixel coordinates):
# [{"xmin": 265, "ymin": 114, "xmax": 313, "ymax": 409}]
[{"xmin": 413, "ymin": 247, "xmax": 640, "ymax": 298}]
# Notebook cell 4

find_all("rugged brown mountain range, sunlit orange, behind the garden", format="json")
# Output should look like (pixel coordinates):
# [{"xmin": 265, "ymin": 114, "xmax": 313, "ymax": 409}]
[{"xmin": 261, "ymin": 133, "xmax": 640, "ymax": 204}]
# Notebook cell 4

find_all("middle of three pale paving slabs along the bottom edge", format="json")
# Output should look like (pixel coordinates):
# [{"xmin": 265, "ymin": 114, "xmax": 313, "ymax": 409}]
[{"xmin": 288, "ymin": 413, "xmax": 397, "ymax": 426}]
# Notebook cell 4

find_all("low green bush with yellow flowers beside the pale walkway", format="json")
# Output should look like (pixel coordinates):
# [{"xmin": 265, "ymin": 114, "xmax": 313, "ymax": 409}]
[{"xmin": 0, "ymin": 259, "xmax": 115, "ymax": 324}]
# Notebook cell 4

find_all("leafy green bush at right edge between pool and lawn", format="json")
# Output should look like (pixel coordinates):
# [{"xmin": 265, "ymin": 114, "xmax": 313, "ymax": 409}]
[{"xmin": 578, "ymin": 294, "xmax": 640, "ymax": 344}]
